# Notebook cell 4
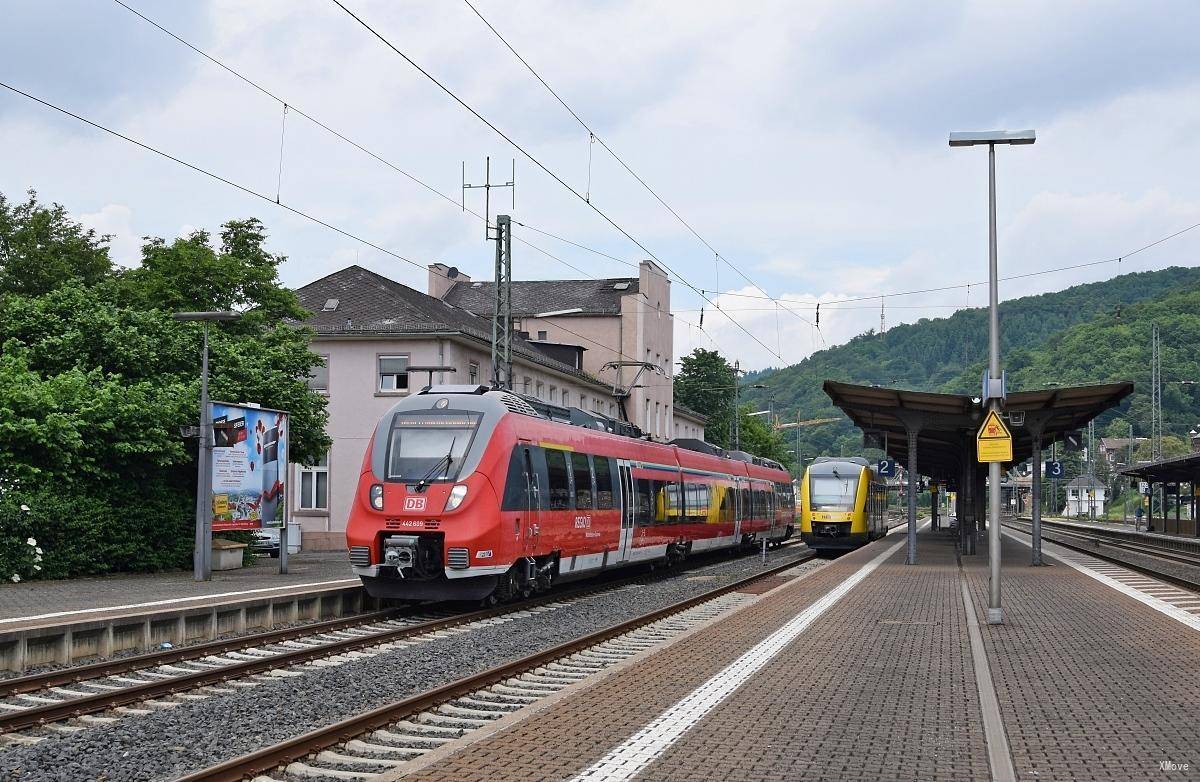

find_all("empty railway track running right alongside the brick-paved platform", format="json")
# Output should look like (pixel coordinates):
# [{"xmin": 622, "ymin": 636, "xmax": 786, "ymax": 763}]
[{"xmin": 179, "ymin": 553, "xmax": 814, "ymax": 782}]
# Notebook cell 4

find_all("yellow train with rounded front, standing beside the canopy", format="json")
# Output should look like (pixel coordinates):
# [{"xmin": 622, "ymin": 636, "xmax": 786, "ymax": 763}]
[{"xmin": 800, "ymin": 456, "xmax": 888, "ymax": 551}]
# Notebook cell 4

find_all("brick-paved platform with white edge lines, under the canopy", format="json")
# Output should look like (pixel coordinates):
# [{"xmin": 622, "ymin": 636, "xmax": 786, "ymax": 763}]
[{"xmin": 384, "ymin": 524, "xmax": 1200, "ymax": 782}]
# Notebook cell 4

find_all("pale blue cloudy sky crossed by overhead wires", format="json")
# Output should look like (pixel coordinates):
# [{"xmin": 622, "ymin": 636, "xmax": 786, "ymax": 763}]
[{"xmin": 0, "ymin": 0, "xmax": 1200, "ymax": 369}]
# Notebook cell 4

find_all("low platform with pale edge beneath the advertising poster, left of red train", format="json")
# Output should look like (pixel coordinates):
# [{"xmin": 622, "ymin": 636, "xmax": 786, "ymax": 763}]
[{"xmin": 0, "ymin": 552, "xmax": 360, "ymax": 673}]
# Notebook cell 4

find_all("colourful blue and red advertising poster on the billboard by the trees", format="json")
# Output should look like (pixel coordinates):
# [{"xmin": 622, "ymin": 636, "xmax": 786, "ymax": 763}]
[{"xmin": 212, "ymin": 402, "xmax": 288, "ymax": 531}]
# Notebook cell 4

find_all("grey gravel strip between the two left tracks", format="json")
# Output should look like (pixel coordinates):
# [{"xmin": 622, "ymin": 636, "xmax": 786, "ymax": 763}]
[{"xmin": 0, "ymin": 547, "xmax": 823, "ymax": 782}]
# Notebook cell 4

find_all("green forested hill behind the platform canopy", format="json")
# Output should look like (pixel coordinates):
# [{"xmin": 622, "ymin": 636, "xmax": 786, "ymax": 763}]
[{"xmin": 743, "ymin": 267, "xmax": 1200, "ymax": 458}]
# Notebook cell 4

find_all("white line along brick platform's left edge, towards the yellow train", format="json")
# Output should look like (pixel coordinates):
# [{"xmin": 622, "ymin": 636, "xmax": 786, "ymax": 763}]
[{"xmin": 571, "ymin": 525, "xmax": 924, "ymax": 782}]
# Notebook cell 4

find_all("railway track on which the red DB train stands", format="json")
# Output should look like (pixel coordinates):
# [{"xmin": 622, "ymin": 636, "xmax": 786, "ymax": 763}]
[{"xmin": 0, "ymin": 542, "xmax": 794, "ymax": 744}]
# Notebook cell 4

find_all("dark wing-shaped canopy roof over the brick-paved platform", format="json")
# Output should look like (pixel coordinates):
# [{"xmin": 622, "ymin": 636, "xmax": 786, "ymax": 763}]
[{"xmin": 823, "ymin": 380, "xmax": 1133, "ymax": 480}]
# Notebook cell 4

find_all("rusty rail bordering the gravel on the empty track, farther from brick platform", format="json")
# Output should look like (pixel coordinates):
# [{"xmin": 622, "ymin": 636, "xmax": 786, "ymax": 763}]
[{"xmin": 176, "ymin": 552, "xmax": 816, "ymax": 782}]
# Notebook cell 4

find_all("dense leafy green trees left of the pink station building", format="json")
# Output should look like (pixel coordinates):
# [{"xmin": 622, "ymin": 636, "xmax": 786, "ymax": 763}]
[{"xmin": 0, "ymin": 194, "xmax": 329, "ymax": 578}]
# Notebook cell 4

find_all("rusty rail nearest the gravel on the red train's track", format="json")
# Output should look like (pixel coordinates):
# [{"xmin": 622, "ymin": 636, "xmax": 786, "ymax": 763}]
[{"xmin": 0, "ymin": 543, "xmax": 806, "ymax": 735}]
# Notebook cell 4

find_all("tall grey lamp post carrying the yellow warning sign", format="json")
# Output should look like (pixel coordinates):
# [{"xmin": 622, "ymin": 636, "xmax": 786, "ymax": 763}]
[{"xmin": 950, "ymin": 131, "xmax": 1037, "ymax": 625}]
